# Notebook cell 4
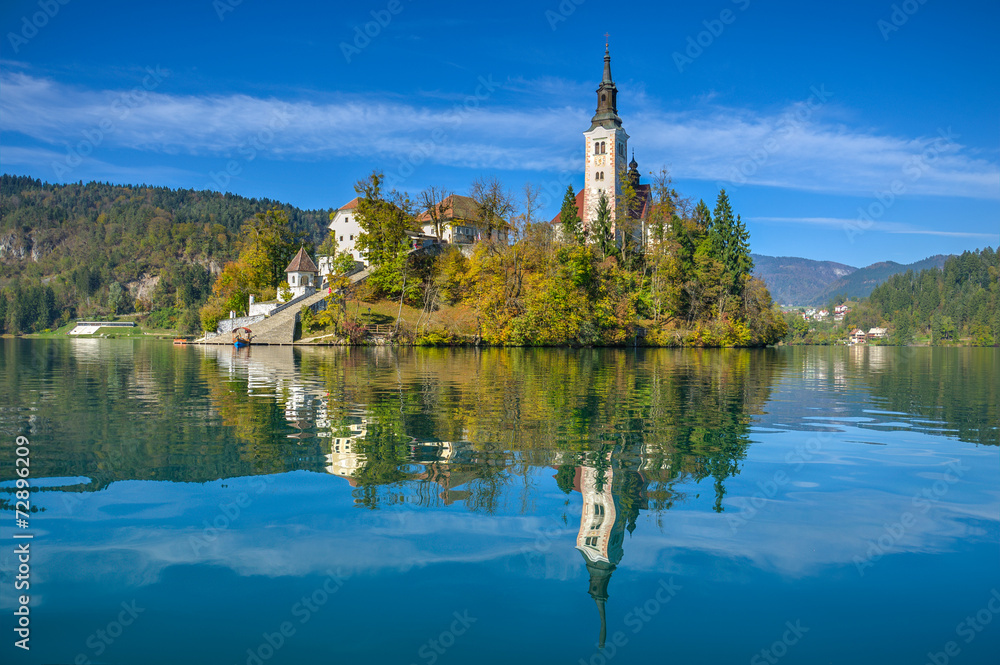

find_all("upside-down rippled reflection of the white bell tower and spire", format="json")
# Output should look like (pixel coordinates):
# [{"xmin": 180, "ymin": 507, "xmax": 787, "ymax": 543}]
[{"xmin": 574, "ymin": 454, "xmax": 625, "ymax": 648}]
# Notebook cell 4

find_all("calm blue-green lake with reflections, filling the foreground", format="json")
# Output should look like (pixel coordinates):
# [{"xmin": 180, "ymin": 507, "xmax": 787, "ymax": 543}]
[{"xmin": 0, "ymin": 339, "xmax": 1000, "ymax": 665}]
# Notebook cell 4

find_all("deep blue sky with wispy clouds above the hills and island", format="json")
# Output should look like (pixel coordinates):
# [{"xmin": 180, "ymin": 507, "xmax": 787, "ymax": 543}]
[{"xmin": 0, "ymin": 0, "xmax": 1000, "ymax": 266}]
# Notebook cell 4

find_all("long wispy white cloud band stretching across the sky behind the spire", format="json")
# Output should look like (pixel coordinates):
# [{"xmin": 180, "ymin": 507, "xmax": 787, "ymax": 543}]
[{"xmin": 0, "ymin": 72, "xmax": 1000, "ymax": 200}]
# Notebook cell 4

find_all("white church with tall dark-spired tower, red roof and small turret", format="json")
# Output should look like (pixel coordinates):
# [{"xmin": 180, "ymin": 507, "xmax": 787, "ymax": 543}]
[{"xmin": 552, "ymin": 44, "xmax": 651, "ymax": 244}]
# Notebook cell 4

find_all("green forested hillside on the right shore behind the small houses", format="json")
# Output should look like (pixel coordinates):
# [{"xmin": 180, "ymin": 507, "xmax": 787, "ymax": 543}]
[{"xmin": 848, "ymin": 247, "xmax": 1000, "ymax": 346}]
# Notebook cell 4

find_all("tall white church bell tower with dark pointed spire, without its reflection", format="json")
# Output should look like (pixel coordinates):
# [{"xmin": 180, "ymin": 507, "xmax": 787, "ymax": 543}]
[{"xmin": 583, "ymin": 44, "xmax": 629, "ymax": 229}]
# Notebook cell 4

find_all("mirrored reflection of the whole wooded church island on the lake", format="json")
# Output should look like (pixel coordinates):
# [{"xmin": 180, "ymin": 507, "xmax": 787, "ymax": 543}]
[{"xmin": 189, "ymin": 347, "xmax": 780, "ymax": 647}]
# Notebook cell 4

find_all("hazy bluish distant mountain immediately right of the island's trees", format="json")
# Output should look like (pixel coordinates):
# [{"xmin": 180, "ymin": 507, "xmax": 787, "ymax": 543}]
[{"xmin": 751, "ymin": 254, "xmax": 856, "ymax": 305}]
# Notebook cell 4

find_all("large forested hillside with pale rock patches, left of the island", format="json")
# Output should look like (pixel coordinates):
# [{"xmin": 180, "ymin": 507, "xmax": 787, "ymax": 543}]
[{"xmin": 0, "ymin": 175, "xmax": 329, "ymax": 334}]
